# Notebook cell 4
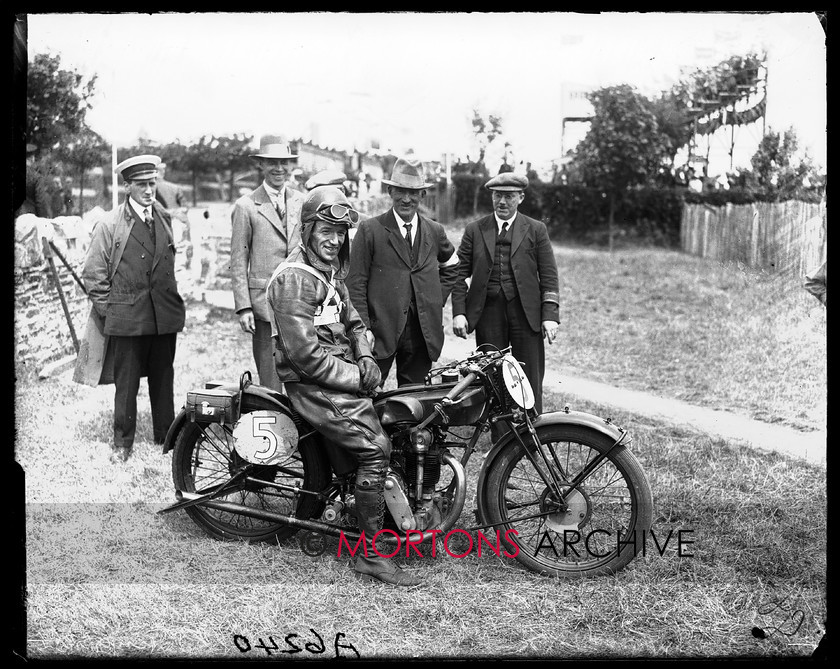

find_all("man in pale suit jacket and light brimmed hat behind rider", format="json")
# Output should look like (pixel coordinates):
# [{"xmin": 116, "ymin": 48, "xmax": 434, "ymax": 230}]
[{"xmin": 230, "ymin": 137, "xmax": 304, "ymax": 391}]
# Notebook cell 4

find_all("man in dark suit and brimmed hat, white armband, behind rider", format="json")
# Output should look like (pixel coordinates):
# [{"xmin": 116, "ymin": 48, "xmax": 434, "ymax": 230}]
[{"xmin": 347, "ymin": 158, "xmax": 458, "ymax": 385}]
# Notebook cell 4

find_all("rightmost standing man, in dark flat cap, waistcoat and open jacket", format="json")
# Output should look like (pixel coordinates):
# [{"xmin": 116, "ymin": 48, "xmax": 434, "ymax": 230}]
[{"xmin": 452, "ymin": 172, "xmax": 560, "ymax": 412}]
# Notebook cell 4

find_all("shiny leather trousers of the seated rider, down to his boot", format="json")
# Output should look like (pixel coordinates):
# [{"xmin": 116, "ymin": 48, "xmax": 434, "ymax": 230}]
[{"xmin": 285, "ymin": 381, "xmax": 391, "ymax": 539}]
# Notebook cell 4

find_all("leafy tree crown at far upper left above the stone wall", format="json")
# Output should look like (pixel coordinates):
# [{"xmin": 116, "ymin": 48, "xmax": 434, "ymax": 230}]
[{"xmin": 26, "ymin": 54, "xmax": 96, "ymax": 152}]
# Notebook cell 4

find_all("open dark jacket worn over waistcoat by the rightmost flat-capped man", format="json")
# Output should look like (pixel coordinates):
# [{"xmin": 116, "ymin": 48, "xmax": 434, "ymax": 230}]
[{"xmin": 452, "ymin": 213, "xmax": 560, "ymax": 332}]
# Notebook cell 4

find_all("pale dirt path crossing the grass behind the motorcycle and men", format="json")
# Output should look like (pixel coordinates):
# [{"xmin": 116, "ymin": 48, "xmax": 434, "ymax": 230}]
[{"xmin": 205, "ymin": 291, "xmax": 826, "ymax": 466}]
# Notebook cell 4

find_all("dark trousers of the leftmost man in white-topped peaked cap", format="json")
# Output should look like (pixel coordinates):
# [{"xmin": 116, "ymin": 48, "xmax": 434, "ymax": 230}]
[{"xmin": 110, "ymin": 332, "xmax": 177, "ymax": 448}]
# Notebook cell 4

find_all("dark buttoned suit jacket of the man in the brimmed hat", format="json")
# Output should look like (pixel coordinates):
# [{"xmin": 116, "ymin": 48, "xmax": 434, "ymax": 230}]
[{"xmin": 346, "ymin": 208, "xmax": 456, "ymax": 360}]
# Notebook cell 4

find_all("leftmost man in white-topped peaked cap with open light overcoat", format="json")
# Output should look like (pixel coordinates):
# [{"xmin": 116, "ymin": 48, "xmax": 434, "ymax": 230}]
[{"xmin": 74, "ymin": 155, "xmax": 186, "ymax": 462}]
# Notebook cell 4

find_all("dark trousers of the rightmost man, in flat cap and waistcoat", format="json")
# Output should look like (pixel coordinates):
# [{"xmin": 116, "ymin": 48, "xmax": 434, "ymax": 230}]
[{"xmin": 475, "ymin": 291, "xmax": 545, "ymax": 413}]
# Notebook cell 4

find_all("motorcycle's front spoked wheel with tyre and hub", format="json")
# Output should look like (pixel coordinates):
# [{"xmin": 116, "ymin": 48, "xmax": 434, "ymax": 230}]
[{"xmin": 480, "ymin": 425, "xmax": 653, "ymax": 577}]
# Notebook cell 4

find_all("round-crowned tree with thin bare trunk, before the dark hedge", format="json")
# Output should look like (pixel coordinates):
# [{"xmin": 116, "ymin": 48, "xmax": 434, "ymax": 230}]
[{"xmin": 573, "ymin": 84, "xmax": 675, "ymax": 251}]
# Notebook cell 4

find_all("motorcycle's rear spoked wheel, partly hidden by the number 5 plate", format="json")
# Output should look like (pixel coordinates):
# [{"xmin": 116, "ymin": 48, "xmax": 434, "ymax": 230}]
[{"xmin": 172, "ymin": 396, "xmax": 329, "ymax": 541}]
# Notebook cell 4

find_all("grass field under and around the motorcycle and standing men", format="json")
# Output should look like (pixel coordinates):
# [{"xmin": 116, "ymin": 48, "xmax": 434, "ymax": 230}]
[{"xmin": 15, "ymin": 236, "xmax": 826, "ymax": 659}]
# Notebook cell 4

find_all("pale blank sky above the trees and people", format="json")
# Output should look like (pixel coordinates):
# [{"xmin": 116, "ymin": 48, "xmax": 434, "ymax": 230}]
[{"xmin": 28, "ymin": 12, "xmax": 827, "ymax": 173}]
